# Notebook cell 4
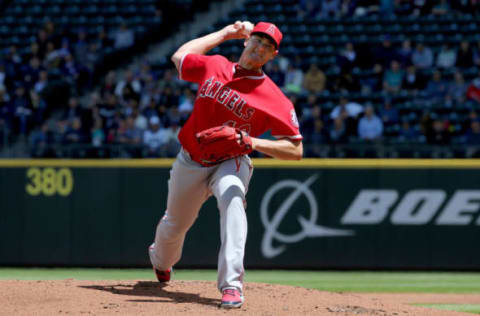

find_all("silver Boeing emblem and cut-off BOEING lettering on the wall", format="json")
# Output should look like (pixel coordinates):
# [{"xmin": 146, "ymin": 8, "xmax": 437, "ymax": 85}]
[{"xmin": 260, "ymin": 174, "xmax": 480, "ymax": 258}]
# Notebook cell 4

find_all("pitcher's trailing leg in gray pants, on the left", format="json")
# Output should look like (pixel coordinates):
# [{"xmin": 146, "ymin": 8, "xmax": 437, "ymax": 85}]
[{"xmin": 149, "ymin": 150, "xmax": 210, "ymax": 271}]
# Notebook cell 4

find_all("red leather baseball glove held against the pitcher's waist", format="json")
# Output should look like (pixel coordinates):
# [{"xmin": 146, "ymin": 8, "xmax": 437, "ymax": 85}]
[{"xmin": 196, "ymin": 126, "xmax": 252, "ymax": 164}]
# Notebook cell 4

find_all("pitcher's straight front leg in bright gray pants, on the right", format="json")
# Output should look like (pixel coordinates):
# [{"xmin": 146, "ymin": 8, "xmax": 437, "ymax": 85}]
[{"xmin": 211, "ymin": 157, "xmax": 252, "ymax": 294}]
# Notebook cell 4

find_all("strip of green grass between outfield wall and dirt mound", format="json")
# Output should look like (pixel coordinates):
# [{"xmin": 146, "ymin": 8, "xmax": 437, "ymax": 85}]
[{"xmin": 0, "ymin": 268, "xmax": 480, "ymax": 314}]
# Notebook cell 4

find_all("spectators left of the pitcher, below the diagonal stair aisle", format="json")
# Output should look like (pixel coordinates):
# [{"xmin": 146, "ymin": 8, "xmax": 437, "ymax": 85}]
[{"xmin": 26, "ymin": 63, "xmax": 187, "ymax": 157}]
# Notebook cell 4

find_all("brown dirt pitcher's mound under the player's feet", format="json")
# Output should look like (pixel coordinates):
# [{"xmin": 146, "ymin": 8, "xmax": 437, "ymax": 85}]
[{"xmin": 0, "ymin": 279, "xmax": 471, "ymax": 316}]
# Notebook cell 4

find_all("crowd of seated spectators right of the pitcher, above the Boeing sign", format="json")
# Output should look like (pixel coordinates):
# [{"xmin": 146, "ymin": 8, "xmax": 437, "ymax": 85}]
[{"xmin": 258, "ymin": 35, "xmax": 480, "ymax": 154}]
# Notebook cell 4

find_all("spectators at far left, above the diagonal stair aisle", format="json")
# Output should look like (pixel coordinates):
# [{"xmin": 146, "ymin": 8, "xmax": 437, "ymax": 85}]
[{"xmin": 0, "ymin": 18, "xmax": 148, "ymax": 155}]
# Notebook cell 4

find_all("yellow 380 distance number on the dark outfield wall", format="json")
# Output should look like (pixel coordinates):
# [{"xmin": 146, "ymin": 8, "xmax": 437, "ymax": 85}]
[{"xmin": 25, "ymin": 167, "xmax": 73, "ymax": 196}]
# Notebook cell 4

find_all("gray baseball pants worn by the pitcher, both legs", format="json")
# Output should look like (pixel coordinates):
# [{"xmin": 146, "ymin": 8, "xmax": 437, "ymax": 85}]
[{"xmin": 149, "ymin": 148, "xmax": 253, "ymax": 293}]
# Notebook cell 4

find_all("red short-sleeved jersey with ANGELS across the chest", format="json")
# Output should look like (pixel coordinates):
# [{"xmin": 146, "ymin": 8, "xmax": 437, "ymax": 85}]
[{"xmin": 178, "ymin": 54, "xmax": 302, "ymax": 160}]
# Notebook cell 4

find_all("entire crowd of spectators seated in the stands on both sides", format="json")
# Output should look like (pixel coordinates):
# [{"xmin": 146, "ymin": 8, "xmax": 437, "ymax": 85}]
[{"xmin": 0, "ymin": 0, "xmax": 480, "ymax": 157}]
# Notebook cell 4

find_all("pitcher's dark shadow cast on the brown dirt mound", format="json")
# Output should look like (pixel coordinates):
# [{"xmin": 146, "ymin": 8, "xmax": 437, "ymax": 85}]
[{"xmin": 79, "ymin": 281, "xmax": 220, "ymax": 306}]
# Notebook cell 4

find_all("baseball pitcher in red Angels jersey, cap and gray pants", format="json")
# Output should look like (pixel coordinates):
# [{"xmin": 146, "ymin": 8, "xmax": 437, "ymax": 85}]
[{"xmin": 149, "ymin": 21, "xmax": 303, "ymax": 308}]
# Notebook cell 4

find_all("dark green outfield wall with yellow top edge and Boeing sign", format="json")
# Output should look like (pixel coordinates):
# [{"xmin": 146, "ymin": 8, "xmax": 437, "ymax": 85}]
[{"xmin": 0, "ymin": 159, "xmax": 480, "ymax": 270}]
